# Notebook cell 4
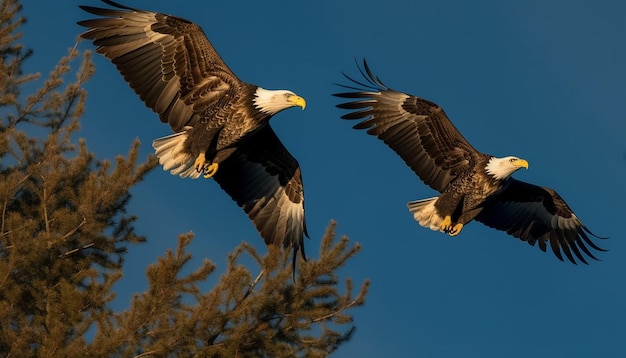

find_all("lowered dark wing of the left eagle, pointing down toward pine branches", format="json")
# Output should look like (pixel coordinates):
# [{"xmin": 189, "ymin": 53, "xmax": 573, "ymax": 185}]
[{"xmin": 215, "ymin": 125, "xmax": 308, "ymax": 260}]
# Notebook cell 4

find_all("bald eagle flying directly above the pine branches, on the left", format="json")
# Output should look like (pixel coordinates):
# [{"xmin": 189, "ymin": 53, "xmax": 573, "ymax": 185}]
[{"xmin": 78, "ymin": 0, "xmax": 308, "ymax": 263}]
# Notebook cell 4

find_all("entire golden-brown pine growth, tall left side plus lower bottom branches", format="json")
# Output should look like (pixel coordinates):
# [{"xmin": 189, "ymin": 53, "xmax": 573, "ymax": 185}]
[{"xmin": 0, "ymin": 0, "xmax": 369, "ymax": 357}]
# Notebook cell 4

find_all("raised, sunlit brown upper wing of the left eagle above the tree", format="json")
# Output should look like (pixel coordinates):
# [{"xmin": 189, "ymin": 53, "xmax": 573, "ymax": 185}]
[{"xmin": 78, "ymin": 0, "xmax": 242, "ymax": 132}]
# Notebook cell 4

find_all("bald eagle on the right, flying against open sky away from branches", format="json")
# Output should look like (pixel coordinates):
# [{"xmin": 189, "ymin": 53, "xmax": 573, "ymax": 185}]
[{"xmin": 335, "ymin": 61, "xmax": 605, "ymax": 264}]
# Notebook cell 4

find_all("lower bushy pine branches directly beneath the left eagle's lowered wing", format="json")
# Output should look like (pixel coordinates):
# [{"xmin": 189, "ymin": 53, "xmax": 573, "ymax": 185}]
[{"xmin": 94, "ymin": 223, "xmax": 369, "ymax": 357}]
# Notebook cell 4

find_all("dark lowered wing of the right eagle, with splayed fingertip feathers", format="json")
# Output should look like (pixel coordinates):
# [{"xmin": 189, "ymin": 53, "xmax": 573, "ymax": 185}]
[{"xmin": 476, "ymin": 178, "xmax": 606, "ymax": 264}]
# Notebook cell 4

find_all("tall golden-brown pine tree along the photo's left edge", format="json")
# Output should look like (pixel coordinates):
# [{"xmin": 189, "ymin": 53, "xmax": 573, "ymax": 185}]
[{"xmin": 0, "ymin": 1, "xmax": 156, "ymax": 356}]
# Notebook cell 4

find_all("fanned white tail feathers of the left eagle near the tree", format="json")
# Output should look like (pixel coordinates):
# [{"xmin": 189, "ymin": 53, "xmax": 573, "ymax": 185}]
[{"xmin": 152, "ymin": 131, "xmax": 200, "ymax": 179}]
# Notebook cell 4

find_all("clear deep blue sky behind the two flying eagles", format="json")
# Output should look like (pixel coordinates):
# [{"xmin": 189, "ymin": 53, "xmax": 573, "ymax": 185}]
[{"xmin": 24, "ymin": 0, "xmax": 626, "ymax": 358}]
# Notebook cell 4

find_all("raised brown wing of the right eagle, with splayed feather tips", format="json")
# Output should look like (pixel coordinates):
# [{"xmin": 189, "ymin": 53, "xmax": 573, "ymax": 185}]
[{"xmin": 335, "ymin": 61, "xmax": 477, "ymax": 191}]
